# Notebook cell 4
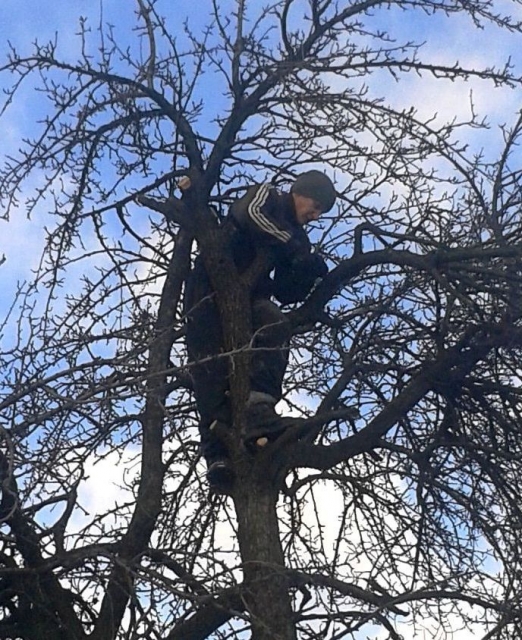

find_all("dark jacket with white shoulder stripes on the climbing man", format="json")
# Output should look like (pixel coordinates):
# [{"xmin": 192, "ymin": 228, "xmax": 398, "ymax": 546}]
[{"xmin": 186, "ymin": 184, "xmax": 328, "ymax": 309}]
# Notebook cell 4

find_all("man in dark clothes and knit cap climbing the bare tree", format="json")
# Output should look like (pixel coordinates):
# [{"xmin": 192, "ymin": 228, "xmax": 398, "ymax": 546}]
[{"xmin": 185, "ymin": 170, "xmax": 335, "ymax": 491}]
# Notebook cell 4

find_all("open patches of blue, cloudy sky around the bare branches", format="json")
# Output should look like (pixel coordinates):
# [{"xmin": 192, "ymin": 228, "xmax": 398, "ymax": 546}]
[{"xmin": 0, "ymin": 0, "xmax": 522, "ymax": 640}]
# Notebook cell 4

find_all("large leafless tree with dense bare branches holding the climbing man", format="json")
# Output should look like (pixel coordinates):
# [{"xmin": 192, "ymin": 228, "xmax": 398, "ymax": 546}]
[{"xmin": 0, "ymin": 0, "xmax": 522, "ymax": 640}]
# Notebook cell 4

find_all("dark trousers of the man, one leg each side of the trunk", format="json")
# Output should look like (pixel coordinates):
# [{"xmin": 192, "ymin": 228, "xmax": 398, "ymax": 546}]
[{"xmin": 186, "ymin": 294, "xmax": 290, "ymax": 462}]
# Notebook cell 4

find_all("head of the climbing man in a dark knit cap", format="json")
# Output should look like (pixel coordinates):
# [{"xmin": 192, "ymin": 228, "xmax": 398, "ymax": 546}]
[{"xmin": 290, "ymin": 170, "xmax": 335, "ymax": 224}]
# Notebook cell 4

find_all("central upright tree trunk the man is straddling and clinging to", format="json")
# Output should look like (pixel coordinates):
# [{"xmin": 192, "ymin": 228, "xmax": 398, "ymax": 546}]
[{"xmin": 198, "ymin": 209, "xmax": 297, "ymax": 640}]
